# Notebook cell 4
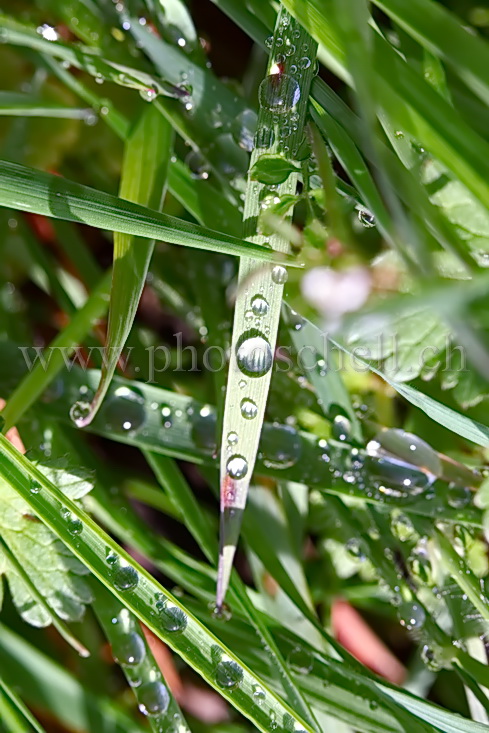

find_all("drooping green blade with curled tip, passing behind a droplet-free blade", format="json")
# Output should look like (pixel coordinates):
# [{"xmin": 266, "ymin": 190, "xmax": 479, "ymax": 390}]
[{"xmin": 75, "ymin": 105, "xmax": 174, "ymax": 427}]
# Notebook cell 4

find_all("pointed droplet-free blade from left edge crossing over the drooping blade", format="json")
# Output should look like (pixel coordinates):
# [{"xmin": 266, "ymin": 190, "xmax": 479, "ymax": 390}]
[{"xmin": 0, "ymin": 161, "xmax": 286, "ymax": 265}]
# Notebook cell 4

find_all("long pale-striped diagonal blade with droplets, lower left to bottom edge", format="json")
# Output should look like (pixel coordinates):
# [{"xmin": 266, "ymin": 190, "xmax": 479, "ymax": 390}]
[{"xmin": 0, "ymin": 436, "xmax": 314, "ymax": 733}]
